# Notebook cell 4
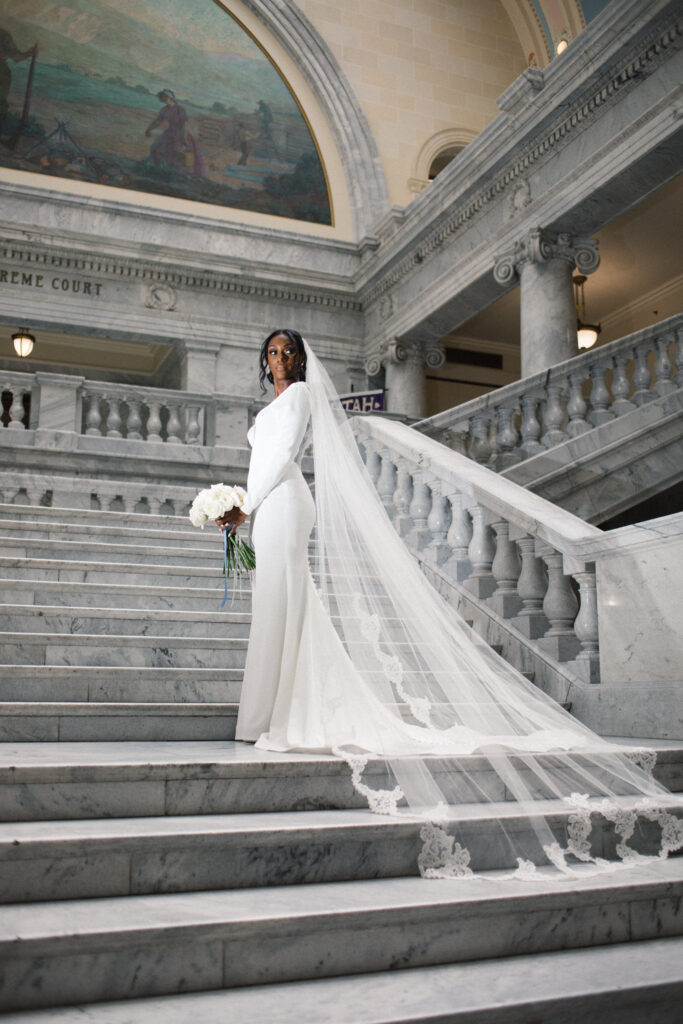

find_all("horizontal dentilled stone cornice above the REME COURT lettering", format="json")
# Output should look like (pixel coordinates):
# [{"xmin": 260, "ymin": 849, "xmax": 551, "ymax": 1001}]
[{"xmin": 0, "ymin": 240, "xmax": 361, "ymax": 312}]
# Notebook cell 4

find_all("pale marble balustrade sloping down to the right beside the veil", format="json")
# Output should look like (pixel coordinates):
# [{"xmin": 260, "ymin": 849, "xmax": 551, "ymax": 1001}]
[{"xmin": 353, "ymin": 419, "xmax": 603, "ymax": 683}]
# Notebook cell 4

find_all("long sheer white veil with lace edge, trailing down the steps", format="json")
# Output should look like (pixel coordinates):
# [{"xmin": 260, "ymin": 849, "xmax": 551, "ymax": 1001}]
[{"xmin": 305, "ymin": 343, "xmax": 683, "ymax": 879}]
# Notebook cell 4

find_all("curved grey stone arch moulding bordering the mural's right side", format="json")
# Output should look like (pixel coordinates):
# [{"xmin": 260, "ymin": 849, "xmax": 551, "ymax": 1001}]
[{"xmin": 242, "ymin": 0, "xmax": 389, "ymax": 239}]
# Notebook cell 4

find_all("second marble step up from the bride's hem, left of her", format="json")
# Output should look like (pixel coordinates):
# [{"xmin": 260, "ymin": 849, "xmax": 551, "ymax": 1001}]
[{"xmin": 0, "ymin": 665, "xmax": 243, "ymax": 703}]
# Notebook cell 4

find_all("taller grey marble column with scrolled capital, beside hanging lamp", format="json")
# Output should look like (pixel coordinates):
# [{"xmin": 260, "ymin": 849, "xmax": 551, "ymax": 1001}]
[{"xmin": 494, "ymin": 227, "xmax": 600, "ymax": 377}]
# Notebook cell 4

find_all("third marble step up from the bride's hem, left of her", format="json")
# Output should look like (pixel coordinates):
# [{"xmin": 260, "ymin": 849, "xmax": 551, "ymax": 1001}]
[{"xmin": 0, "ymin": 628, "xmax": 247, "ymax": 669}]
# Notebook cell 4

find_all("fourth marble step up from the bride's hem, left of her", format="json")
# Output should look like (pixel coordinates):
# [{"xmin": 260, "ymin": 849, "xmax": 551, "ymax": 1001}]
[{"xmin": 0, "ymin": 598, "xmax": 251, "ymax": 637}]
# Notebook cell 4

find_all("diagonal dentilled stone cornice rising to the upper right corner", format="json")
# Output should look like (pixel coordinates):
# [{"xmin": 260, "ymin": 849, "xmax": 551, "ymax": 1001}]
[{"xmin": 360, "ymin": 4, "xmax": 683, "ymax": 308}]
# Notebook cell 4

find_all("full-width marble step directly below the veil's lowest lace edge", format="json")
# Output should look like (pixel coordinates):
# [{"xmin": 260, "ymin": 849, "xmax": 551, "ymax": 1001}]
[{"xmin": 0, "ymin": 858, "xmax": 683, "ymax": 1022}]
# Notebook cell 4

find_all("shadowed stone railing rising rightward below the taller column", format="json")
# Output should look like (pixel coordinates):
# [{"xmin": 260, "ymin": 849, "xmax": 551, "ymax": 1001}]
[{"xmin": 415, "ymin": 314, "xmax": 683, "ymax": 470}]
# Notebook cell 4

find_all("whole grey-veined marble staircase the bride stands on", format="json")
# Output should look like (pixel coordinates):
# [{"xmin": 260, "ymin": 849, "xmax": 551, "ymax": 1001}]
[{"xmin": 0, "ymin": 505, "xmax": 683, "ymax": 1024}]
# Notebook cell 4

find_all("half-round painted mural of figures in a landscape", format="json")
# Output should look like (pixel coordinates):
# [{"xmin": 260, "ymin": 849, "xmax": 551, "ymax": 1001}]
[{"xmin": 0, "ymin": 0, "xmax": 331, "ymax": 224}]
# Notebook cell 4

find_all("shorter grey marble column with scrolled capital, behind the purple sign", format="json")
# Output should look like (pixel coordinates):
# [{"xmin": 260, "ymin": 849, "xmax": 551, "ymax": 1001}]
[{"xmin": 366, "ymin": 341, "xmax": 444, "ymax": 419}]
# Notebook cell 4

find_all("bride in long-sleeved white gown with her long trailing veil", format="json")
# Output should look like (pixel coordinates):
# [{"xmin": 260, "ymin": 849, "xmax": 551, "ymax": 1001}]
[{"xmin": 216, "ymin": 330, "xmax": 683, "ymax": 878}]
